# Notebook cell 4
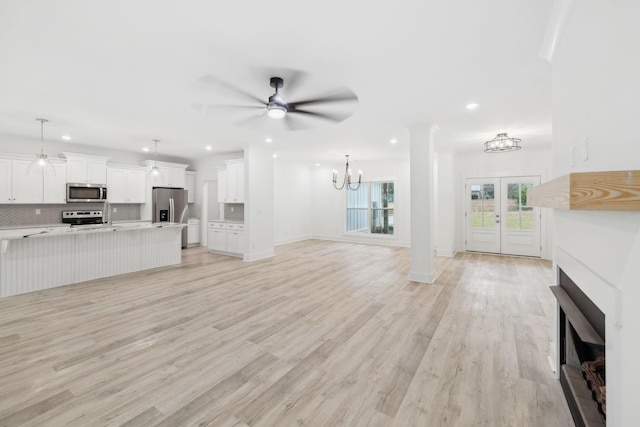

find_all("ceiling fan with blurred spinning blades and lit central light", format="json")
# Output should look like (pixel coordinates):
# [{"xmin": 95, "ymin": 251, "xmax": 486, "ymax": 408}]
[{"xmin": 193, "ymin": 71, "xmax": 358, "ymax": 130}]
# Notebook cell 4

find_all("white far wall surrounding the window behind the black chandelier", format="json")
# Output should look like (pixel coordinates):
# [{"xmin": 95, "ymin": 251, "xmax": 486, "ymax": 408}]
[{"xmin": 310, "ymin": 160, "xmax": 411, "ymax": 246}]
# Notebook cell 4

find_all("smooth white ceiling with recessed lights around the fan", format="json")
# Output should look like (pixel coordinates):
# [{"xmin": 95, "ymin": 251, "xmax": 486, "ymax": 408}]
[{"xmin": 0, "ymin": 0, "xmax": 552, "ymax": 162}]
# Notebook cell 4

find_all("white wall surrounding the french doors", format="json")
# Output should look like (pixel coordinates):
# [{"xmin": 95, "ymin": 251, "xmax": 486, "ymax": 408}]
[{"xmin": 450, "ymin": 145, "xmax": 553, "ymax": 259}]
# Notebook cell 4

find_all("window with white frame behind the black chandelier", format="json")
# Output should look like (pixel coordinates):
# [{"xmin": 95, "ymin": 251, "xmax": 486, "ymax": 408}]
[{"xmin": 347, "ymin": 182, "xmax": 394, "ymax": 235}]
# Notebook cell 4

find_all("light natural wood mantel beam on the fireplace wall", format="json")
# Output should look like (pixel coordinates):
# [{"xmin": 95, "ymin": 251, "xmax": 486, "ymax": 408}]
[{"xmin": 527, "ymin": 170, "xmax": 640, "ymax": 211}]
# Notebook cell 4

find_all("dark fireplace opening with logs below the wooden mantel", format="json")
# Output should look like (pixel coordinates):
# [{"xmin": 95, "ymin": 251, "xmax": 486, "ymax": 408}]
[{"xmin": 551, "ymin": 269, "xmax": 606, "ymax": 427}]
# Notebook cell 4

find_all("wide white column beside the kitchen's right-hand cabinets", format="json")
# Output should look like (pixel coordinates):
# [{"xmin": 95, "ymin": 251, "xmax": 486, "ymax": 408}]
[{"xmin": 244, "ymin": 146, "xmax": 275, "ymax": 261}]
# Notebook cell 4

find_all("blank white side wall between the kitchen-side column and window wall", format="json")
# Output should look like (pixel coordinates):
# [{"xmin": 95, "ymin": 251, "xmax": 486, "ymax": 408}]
[{"xmin": 274, "ymin": 159, "xmax": 314, "ymax": 245}]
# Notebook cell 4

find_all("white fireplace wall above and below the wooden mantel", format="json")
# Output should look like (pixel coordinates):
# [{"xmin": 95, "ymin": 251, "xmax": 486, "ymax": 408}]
[{"xmin": 552, "ymin": 0, "xmax": 640, "ymax": 426}]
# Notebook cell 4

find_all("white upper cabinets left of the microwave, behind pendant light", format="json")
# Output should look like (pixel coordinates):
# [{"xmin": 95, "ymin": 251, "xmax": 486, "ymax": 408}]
[{"xmin": 0, "ymin": 155, "xmax": 66, "ymax": 204}]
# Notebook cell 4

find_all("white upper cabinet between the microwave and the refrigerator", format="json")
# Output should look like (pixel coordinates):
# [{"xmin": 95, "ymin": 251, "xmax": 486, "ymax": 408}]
[{"xmin": 107, "ymin": 165, "xmax": 146, "ymax": 203}]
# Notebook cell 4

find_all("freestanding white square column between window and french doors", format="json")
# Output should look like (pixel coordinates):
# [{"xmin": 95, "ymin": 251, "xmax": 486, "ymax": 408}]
[{"xmin": 408, "ymin": 123, "xmax": 437, "ymax": 283}]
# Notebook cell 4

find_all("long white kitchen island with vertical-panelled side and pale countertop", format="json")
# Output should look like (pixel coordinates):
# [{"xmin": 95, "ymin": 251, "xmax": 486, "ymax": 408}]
[{"xmin": 0, "ymin": 222, "xmax": 186, "ymax": 297}]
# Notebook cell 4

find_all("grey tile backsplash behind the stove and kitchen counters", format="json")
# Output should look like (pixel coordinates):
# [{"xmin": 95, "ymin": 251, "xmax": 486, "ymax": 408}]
[{"xmin": 0, "ymin": 203, "xmax": 140, "ymax": 228}]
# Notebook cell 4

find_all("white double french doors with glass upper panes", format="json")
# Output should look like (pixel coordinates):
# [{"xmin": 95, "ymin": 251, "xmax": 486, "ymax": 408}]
[{"xmin": 465, "ymin": 176, "xmax": 541, "ymax": 256}]
